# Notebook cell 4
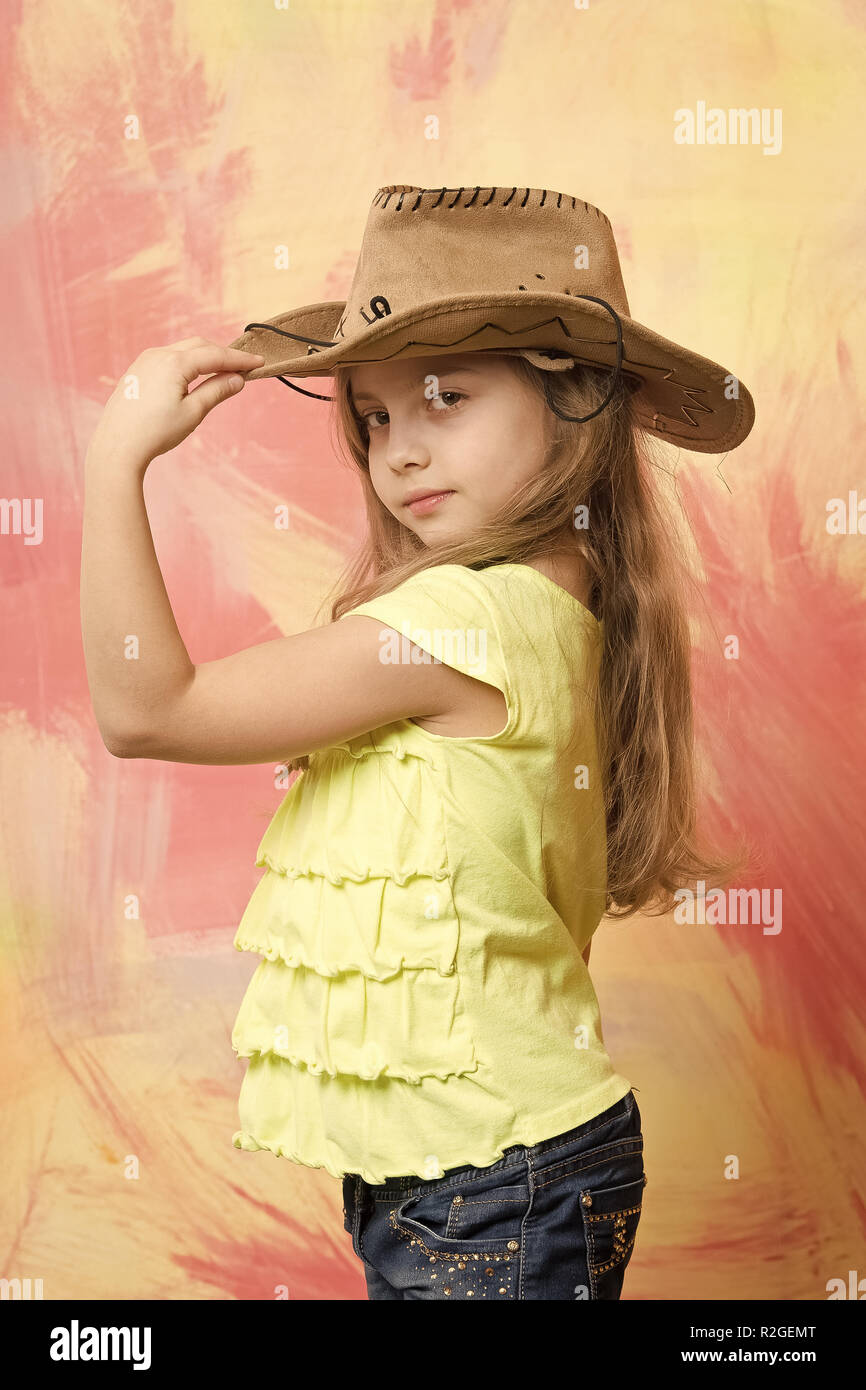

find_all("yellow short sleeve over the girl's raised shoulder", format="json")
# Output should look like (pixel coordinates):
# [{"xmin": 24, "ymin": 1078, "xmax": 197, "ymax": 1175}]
[{"xmin": 341, "ymin": 564, "xmax": 518, "ymax": 742}]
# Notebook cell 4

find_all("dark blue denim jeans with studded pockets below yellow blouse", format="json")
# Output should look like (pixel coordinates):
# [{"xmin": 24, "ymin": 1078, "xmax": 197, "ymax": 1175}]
[{"xmin": 343, "ymin": 1091, "xmax": 646, "ymax": 1302}]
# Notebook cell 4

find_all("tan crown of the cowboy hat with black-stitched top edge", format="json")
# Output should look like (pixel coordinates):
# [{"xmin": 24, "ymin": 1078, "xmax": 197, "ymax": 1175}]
[{"xmin": 334, "ymin": 183, "xmax": 630, "ymax": 343}]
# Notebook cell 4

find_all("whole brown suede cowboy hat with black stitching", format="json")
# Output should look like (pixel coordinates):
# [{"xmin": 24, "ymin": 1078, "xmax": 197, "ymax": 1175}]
[{"xmin": 229, "ymin": 183, "xmax": 755, "ymax": 453}]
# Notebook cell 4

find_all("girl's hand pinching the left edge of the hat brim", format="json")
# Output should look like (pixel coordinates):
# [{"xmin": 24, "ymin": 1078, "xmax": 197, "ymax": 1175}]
[{"xmin": 88, "ymin": 338, "xmax": 264, "ymax": 468}]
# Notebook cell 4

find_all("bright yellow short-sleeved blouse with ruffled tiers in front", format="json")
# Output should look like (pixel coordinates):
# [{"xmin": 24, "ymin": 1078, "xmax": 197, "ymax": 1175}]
[{"xmin": 232, "ymin": 564, "xmax": 631, "ymax": 1183}]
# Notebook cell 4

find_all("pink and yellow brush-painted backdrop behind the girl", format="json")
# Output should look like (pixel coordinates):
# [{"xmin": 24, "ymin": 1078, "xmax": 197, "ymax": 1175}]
[{"xmin": 0, "ymin": 0, "xmax": 866, "ymax": 1300}]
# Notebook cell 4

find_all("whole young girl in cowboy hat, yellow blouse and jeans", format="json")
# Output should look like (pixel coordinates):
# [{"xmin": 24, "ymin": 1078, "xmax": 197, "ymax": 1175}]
[{"xmin": 82, "ymin": 185, "xmax": 753, "ymax": 1301}]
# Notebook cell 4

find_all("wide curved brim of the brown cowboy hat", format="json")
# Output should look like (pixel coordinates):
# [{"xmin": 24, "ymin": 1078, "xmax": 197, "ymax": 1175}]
[{"xmin": 229, "ymin": 292, "xmax": 755, "ymax": 453}]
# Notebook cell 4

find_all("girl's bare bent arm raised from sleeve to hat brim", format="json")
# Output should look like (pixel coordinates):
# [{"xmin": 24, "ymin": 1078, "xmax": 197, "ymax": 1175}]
[{"xmin": 81, "ymin": 341, "xmax": 478, "ymax": 763}]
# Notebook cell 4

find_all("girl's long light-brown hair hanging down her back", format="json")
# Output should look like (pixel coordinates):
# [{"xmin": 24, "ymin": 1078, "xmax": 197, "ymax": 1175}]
[{"xmin": 289, "ymin": 357, "xmax": 748, "ymax": 917}]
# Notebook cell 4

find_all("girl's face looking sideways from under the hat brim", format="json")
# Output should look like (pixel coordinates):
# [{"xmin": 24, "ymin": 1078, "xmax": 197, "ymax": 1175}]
[{"xmin": 349, "ymin": 353, "xmax": 548, "ymax": 545}]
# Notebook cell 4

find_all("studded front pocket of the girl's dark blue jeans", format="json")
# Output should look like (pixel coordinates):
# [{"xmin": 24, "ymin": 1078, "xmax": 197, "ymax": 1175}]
[{"xmin": 389, "ymin": 1169, "xmax": 530, "ymax": 1259}]
